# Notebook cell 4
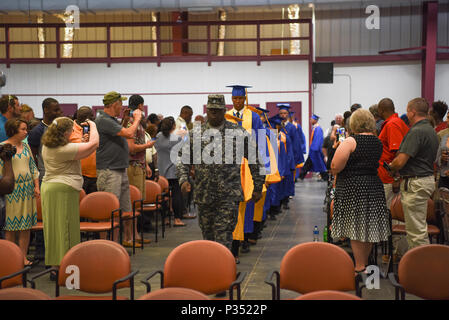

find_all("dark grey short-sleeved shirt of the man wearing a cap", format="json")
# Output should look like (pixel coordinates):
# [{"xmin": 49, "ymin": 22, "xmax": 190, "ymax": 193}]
[{"xmin": 95, "ymin": 111, "xmax": 129, "ymax": 170}]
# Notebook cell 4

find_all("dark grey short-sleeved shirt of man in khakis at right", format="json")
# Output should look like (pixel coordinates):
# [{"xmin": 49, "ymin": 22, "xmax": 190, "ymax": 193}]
[{"xmin": 398, "ymin": 119, "xmax": 438, "ymax": 177}]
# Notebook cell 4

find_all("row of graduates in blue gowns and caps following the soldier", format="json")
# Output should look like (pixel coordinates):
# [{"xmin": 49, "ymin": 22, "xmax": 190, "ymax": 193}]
[{"xmin": 226, "ymin": 85, "xmax": 306, "ymax": 263}]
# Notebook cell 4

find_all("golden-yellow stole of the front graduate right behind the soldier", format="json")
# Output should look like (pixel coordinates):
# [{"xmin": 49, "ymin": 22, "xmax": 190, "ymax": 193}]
[{"xmin": 226, "ymin": 108, "xmax": 254, "ymax": 241}]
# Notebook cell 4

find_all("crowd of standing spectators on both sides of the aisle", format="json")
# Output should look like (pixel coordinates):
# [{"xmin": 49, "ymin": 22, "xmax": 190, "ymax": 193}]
[{"xmin": 0, "ymin": 92, "xmax": 449, "ymax": 272}]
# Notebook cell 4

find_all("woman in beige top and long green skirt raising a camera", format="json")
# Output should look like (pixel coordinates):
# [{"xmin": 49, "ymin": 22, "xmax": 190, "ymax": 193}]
[{"xmin": 41, "ymin": 117, "xmax": 99, "ymax": 278}]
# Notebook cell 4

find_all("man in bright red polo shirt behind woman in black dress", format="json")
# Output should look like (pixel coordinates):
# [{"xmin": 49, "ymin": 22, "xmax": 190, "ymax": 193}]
[{"xmin": 378, "ymin": 98, "xmax": 409, "ymax": 262}]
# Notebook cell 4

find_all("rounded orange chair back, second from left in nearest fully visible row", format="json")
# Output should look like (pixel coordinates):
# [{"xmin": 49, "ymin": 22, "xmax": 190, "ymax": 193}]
[{"xmin": 58, "ymin": 240, "xmax": 131, "ymax": 293}]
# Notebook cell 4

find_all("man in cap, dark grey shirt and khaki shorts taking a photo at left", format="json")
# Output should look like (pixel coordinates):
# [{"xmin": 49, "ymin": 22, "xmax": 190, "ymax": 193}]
[{"xmin": 95, "ymin": 91, "xmax": 142, "ymax": 239}]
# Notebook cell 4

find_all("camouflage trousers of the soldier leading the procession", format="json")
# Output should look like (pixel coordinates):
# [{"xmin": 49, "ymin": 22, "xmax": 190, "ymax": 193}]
[{"xmin": 198, "ymin": 199, "xmax": 239, "ymax": 250}]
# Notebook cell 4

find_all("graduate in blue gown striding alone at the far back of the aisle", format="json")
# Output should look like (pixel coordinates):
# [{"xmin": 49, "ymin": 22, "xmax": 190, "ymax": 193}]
[{"xmin": 299, "ymin": 114, "xmax": 328, "ymax": 181}]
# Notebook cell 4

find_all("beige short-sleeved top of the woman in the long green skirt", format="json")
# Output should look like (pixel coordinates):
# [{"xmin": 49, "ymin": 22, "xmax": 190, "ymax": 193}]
[{"xmin": 42, "ymin": 143, "xmax": 83, "ymax": 190}]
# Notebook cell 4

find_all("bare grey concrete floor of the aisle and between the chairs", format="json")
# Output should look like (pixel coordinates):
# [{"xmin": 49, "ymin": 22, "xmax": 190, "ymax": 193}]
[{"xmin": 31, "ymin": 178, "xmax": 416, "ymax": 300}]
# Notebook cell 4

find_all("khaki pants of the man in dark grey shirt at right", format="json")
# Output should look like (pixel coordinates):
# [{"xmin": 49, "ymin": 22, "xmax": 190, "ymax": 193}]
[{"xmin": 401, "ymin": 176, "xmax": 435, "ymax": 249}]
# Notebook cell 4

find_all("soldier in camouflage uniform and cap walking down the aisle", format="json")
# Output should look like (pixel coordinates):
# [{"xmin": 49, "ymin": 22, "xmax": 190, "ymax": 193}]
[{"xmin": 177, "ymin": 95, "xmax": 265, "ymax": 249}]
